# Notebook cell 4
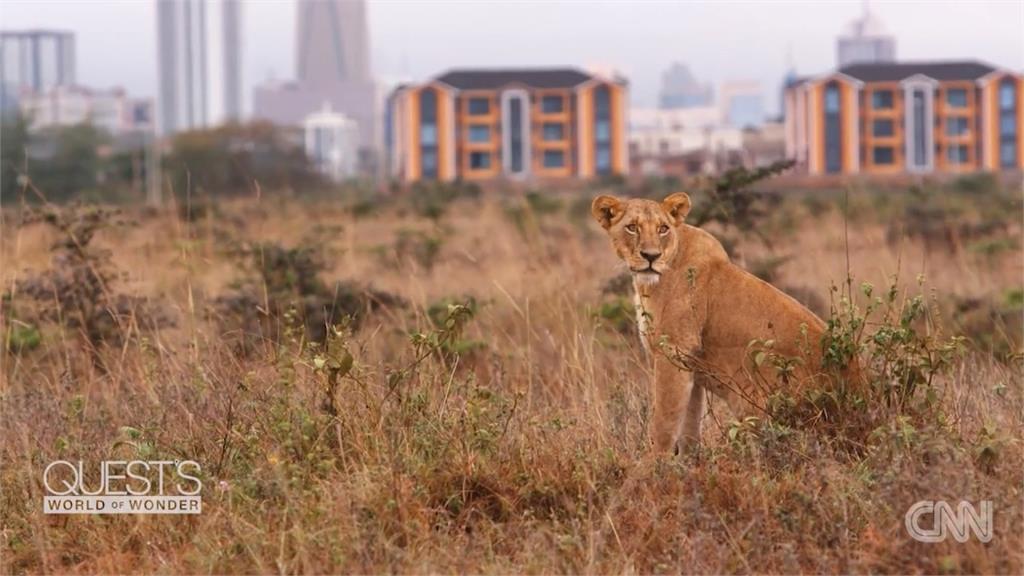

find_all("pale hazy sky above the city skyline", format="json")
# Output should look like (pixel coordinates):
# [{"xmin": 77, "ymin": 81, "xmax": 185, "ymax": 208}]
[{"xmin": 0, "ymin": 0, "xmax": 1024, "ymax": 114}]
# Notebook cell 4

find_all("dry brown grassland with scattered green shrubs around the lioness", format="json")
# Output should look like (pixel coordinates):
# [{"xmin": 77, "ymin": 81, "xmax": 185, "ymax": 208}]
[{"xmin": 0, "ymin": 174, "xmax": 1024, "ymax": 573}]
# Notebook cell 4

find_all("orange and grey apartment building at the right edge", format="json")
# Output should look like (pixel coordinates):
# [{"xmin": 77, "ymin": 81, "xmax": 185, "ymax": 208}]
[{"xmin": 784, "ymin": 61, "xmax": 1024, "ymax": 174}]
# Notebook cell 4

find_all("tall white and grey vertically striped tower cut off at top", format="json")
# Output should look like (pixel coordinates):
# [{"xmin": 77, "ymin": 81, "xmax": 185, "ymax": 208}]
[{"xmin": 157, "ymin": 0, "xmax": 242, "ymax": 134}]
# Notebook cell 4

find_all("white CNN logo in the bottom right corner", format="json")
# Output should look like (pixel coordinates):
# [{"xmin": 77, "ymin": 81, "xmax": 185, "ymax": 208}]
[{"xmin": 904, "ymin": 500, "xmax": 992, "ymax": 544}]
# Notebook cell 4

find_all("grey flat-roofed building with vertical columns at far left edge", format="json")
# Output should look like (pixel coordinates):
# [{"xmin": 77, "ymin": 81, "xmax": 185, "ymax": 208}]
[{"xmin": 0, "ymin": 30, "xmax": 75, "ymax": 110}]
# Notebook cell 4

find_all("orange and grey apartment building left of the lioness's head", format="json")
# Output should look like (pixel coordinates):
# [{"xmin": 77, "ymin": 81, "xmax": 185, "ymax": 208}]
[{"xmin": 387, "ymin": 69, "xmax": 629, "ymax": 181}]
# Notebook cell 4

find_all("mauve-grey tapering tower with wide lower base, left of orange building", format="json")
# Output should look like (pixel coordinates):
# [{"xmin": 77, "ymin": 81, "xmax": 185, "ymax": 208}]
[{"xmin": 253, "ymin": 0, "xmax": 382, "ymax": 157}]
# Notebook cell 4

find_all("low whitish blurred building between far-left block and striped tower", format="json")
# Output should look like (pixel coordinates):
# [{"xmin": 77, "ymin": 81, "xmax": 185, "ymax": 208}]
[{"xmin": 19, "ymin": 86, "xmax": 154, "ymax": 136}]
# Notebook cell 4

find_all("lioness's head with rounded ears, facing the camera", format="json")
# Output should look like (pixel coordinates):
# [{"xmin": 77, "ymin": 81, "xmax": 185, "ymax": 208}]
[{"xmin": 591, "ymin": 192, "xmax": 690, "ymax": 284}]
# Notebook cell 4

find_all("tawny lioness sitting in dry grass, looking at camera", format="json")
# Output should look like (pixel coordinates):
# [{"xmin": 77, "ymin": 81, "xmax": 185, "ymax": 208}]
[{"xmin": 591, "ymin": 193, "xmax": 824, "ymax": 452}]
